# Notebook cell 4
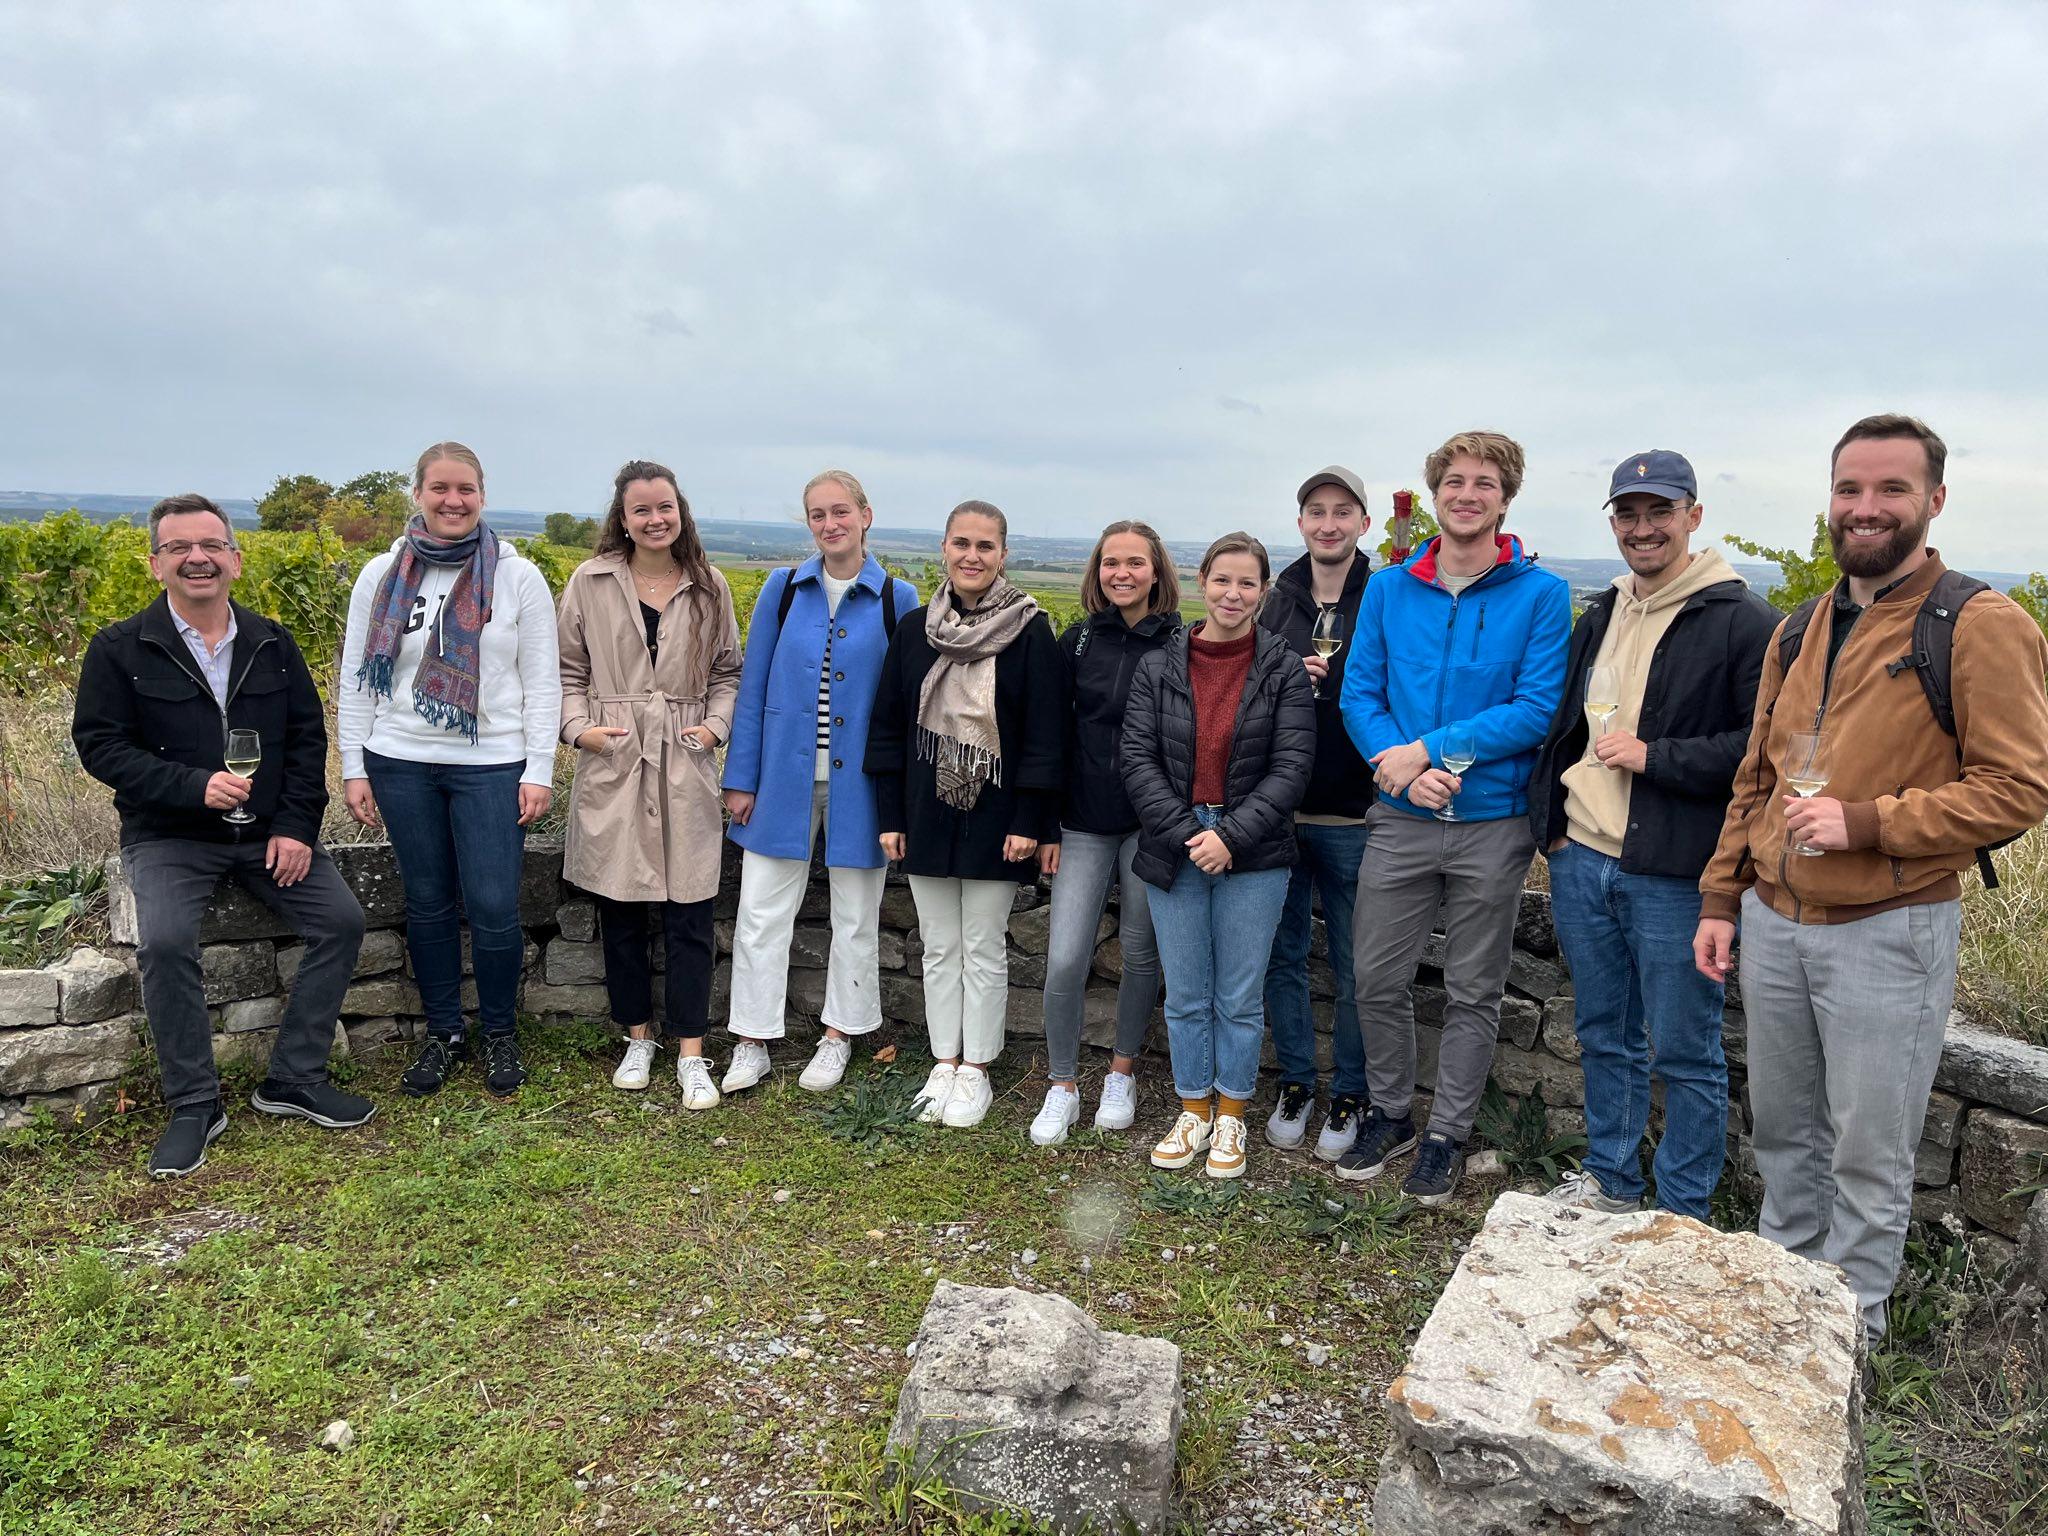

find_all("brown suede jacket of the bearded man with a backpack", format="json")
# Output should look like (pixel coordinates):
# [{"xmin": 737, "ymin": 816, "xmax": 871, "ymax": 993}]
[{"xmin": 1700, "ymin": 549, "xmax": 2048, "ymax": 924}]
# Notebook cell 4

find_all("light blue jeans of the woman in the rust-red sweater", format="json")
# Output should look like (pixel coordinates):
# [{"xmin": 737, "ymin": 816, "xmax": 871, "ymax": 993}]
[{"xmin": 1151, "ymin": 805, "xmax": 1288, "ymax": 1098}]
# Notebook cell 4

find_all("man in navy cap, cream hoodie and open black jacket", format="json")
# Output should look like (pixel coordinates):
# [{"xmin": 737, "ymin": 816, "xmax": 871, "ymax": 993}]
[{"xmin": 1530, "ymin": 451, "xmax": 1778, "ymax": 1221}]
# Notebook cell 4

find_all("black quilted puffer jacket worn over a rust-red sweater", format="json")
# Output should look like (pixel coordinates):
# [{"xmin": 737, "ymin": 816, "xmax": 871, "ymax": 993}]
[{"xmin": 1122, "ymin": 629, "xmax": 1315, "ymax": 891}]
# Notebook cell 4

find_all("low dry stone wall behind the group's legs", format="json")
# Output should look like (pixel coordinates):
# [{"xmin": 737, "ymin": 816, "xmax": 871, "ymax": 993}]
[{"xmin": 0, "ymin": 838, "xmax": 2048, "ymax": 1280}]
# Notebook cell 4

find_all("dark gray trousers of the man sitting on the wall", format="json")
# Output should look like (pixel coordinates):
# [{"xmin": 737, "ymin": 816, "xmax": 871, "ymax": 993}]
[{"xmin": 121, "ymin": 838, "xmax": 362, "ymax": 1110}]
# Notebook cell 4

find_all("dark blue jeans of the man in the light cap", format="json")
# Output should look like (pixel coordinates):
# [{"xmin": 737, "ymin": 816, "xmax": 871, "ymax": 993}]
[{"xmin": 1266, "ymin": 821, "xmax": 1366, "ymax": 1100}]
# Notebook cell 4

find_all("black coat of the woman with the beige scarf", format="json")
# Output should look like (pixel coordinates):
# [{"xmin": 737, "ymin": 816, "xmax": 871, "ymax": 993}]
[{"xmin": 864, "ymin": 608, "xmax": 1067, "ymax": 885}]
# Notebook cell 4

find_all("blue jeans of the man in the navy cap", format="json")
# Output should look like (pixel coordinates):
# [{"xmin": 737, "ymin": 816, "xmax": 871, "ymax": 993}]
[{"xmin": 1550, "ymin": 842, "xmax": 1729, "ymax": 1221}]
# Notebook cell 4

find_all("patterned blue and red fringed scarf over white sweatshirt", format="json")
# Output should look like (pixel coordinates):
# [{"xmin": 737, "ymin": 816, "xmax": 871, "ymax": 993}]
[{"xmin": 356, "ymin": 512, "xmax": 498, "ymax": 741}]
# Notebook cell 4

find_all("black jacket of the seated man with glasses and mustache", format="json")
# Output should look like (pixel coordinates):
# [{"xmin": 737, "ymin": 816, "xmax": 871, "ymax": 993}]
[{"xmin": 72, "ymin": 596, "xmax": 328, "ymax": 846}]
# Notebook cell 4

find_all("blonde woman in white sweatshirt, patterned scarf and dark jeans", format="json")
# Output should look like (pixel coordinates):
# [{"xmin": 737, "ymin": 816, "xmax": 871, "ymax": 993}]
[{"xmin": 336, "ymin": 442, "xmax": 561, "ymax": 1098}]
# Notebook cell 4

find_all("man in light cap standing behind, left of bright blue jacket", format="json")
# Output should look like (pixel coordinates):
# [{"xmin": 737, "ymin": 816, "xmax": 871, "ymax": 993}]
[{"xmin": 1260, "ymin": 465, "xmax": 1372, "ymax": 1163}]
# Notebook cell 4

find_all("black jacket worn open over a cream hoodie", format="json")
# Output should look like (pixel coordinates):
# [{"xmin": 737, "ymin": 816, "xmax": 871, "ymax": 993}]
[{"xmin": 1530, "ymin": 582, "xmax": 1782, "ymax": 881}]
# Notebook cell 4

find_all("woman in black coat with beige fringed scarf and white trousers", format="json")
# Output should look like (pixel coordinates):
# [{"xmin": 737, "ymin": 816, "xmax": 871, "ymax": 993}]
[{"xmin": 866, "ymin": 502, "xmax": 1065, "ymax": 1126}]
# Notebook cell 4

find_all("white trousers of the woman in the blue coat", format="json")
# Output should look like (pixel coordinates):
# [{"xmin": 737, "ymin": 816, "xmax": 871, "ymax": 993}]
[{"xmin": 727, "ymin": 784, "xmax": 889, "ymax": 1040}]
